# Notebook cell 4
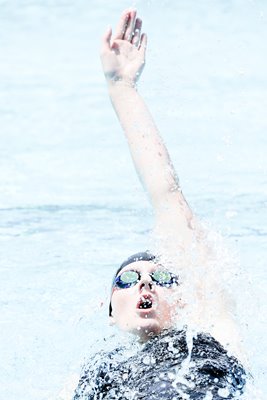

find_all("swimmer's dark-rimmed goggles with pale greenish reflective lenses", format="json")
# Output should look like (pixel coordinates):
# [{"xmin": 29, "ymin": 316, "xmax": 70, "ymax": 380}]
[{"xmin": 113, "ymin": 269, "xmax": 178, "ymax": 289}]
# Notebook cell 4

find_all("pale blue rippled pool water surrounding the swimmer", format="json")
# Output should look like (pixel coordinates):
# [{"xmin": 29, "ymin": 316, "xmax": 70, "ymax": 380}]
[{"xmin": 0, "ymin": 0, "xmax": 267, "ymax": 400}]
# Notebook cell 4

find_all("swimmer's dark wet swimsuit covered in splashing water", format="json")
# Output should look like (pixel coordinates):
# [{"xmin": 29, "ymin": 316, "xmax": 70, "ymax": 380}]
[{"xmin": 73, "ymin": 330, "xmax": 245, "ymax": 400}]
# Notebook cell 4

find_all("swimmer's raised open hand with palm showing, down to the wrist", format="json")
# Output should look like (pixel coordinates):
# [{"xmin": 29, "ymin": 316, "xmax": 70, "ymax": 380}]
[{"xmin": 101, "ymin": 10, "xmax": 147, "ymax": 86}]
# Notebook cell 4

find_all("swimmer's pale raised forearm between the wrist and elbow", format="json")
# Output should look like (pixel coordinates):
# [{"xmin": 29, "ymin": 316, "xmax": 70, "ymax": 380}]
[{"xmin": 109, "ymin": 81, "xmax": 180, "ymax": 206}]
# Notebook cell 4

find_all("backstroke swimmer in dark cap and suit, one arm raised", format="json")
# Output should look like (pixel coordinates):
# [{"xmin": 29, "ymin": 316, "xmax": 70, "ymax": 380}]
[{"xmin": 62, "ymin": 9, "xmax": 249, "ymax": 400}]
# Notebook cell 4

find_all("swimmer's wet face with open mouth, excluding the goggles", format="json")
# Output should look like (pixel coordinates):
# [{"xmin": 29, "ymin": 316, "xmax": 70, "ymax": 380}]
[{"xmin": 110, "ymin": 261, "xmax": 182, "ymax": 340}]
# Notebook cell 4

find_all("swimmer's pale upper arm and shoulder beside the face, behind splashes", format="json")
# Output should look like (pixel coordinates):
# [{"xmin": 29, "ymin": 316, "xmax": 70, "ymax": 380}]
[{"xmin": 154, "ymin": 191, "xmax": 246, "ymax": 355}]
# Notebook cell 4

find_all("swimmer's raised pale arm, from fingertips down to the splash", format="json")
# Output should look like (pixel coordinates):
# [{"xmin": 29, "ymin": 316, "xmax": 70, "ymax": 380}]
[{"xmin": 101, "ymin": 10, "xmax": 205, "ymax": 258}]
